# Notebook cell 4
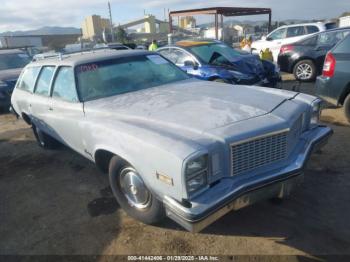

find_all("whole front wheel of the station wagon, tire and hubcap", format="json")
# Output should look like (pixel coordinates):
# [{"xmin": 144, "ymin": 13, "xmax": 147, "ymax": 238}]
[{"xmin": 109, "ymin": 156, "xmax": 165, "ymax": 225}]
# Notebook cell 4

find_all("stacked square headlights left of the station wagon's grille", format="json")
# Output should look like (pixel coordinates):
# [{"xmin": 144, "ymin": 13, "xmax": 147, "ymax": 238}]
[{"xmin": 185, "ymin": 154, "xmax": 208, "ymax": 193}]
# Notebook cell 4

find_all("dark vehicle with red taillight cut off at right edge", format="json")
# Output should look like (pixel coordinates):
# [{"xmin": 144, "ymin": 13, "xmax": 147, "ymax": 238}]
[{"xmin": 316, "ymin": 34, "xmax": 350, "ymax": 122}]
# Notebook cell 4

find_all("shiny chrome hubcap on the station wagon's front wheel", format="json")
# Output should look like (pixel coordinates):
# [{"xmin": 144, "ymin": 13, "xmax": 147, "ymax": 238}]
[{"xmin": 119, "ymin": 167, "xmax": 151, "ymax": 209}]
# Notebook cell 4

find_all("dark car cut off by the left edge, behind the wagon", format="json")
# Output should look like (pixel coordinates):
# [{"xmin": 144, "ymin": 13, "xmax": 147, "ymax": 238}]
[{"xmin": 0, "ymin": 49, "xmax": 30, "ymax": 111}]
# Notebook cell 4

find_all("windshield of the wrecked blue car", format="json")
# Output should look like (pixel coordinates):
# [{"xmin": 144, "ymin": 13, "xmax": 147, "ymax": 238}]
[{"xmin": 188, "ymin": 43, "xmax": 245, "ymax": 65}]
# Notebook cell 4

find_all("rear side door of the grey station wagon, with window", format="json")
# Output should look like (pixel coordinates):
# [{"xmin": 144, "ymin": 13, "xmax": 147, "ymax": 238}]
[{"xmin": 29, "ymin": 66, "xmax": 55, "ymax": 135}]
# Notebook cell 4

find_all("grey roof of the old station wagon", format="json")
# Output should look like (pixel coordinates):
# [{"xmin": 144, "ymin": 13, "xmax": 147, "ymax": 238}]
[{"xmin": 28, "ymin": 49, "xmax": 154, "ymax": 67}]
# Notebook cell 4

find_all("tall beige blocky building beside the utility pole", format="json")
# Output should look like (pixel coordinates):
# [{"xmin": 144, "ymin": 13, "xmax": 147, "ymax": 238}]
[{"xmin": 81, "ymin": 15, "xmax": 111, "ymax": 41}]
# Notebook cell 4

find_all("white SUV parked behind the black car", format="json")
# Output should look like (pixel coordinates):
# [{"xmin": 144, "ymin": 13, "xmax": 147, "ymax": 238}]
[{"xmin": 251, "ymin": 22, "xmax": 331, "ymax": 63}]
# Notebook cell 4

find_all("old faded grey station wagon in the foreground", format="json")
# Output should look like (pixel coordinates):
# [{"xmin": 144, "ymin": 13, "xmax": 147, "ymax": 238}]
[{"xmin": 12, "ymin": 50, "xmax": 332, "ymax": 232}]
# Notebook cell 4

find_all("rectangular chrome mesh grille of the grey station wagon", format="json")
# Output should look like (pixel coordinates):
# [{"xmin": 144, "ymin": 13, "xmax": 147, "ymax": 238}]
[{"xmin": 231, "ymin": 131, "xmax": 288, "ymax": 176}]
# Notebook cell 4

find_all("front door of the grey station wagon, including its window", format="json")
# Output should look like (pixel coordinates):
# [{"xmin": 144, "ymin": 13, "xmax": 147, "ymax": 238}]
[{"xmin": 48, "ymin": 66, "xmax": 84, "ymax": 154}]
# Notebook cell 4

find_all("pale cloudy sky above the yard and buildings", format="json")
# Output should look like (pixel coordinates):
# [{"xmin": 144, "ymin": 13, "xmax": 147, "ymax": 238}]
[{"xmin": 0, "ymin": 0, "xmax": 350, "ymax": 32}]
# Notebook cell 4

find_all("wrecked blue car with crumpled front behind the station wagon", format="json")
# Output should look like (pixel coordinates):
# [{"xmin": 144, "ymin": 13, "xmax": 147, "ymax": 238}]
[{"xmin": 157, "ymin": 40, "xmax": 280, "ymax": 87}]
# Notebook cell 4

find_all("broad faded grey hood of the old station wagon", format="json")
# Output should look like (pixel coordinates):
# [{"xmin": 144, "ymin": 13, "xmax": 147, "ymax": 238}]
[{"xmin": 84, "ymin": 79, "xmax": 295, "ymax": 133}]
